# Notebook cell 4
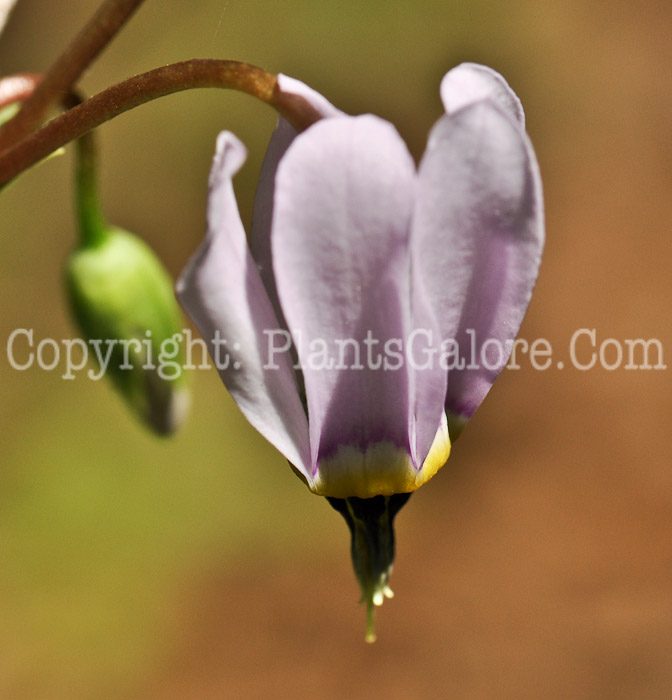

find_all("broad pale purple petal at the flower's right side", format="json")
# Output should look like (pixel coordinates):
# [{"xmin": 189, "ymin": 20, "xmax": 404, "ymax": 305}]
[{"xmin": 413, "ymin": 101, "xmax": 544, "ymax": 430}]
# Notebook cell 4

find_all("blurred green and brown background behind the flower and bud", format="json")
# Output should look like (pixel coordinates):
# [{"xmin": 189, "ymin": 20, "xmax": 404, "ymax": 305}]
[{"xmin": 0, "ymin": 0, "xmax": 672, "ymax": 700}]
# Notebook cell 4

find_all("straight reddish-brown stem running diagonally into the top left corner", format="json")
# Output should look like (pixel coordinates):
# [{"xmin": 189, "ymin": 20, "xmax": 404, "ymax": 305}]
[{"xmin": 0, "ymin": 0, "xmax": 144, "ymax": 152}]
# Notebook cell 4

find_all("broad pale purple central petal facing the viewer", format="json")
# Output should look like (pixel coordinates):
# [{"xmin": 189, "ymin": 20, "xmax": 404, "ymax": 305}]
[{"xmin": 271, "ymin": 116, "xmax": 415, "ymax": 464}]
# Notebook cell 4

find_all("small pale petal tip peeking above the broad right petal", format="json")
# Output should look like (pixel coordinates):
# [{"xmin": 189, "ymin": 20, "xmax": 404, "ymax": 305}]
[{"xmin": 441, "ymin": 63, "xmax": 525, "ymax": 129}]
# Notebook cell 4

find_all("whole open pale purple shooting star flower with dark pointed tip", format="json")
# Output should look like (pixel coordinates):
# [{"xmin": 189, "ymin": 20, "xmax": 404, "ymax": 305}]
[{"xmin": 177, "ymin": 64, "xmax": 544, "ymax": 638}]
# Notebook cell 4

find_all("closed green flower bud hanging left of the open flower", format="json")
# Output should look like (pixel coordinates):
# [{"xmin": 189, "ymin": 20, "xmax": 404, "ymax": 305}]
[{"xmin": 66, "ymin": 226, "xmax": 189, "ymax": 435}]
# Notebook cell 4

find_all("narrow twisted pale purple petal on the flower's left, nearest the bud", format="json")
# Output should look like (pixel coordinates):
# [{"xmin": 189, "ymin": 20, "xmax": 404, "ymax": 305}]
[{"xmin": 177, "ymin": 132, "xmax": 311, "ymax": 485}]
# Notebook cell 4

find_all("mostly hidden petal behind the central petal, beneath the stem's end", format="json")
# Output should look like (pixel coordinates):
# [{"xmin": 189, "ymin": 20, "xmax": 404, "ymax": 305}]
[{"xmin": 250, "ymin": 74, "xmax": 343, "ymax": 319}]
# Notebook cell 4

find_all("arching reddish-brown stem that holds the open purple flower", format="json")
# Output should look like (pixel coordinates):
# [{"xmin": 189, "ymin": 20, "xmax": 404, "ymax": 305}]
[{"xmin": 0, "ymin": 59, "xmax": 320, "ymax": 187}]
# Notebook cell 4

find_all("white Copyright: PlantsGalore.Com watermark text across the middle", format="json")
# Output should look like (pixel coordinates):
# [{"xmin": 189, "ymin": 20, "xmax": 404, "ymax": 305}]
[{"xmin": 5, "ymin": 328, "xmax": 667, "ymax": 381}]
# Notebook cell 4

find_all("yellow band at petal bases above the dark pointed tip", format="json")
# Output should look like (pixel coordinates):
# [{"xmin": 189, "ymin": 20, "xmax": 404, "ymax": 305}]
[{"xmin": 311, "ymin": 419, "xmax": 450, "ymax": 498}]
